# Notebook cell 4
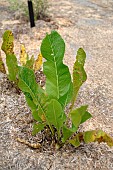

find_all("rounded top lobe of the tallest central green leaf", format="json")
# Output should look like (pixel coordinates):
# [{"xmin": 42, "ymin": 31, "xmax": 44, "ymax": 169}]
[{"xmin": 41, "ymin": 31, "xmax": 65, "ymax": 63}]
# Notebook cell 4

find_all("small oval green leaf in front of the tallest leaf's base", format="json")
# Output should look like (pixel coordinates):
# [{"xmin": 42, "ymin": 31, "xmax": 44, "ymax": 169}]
[{"xmin": 46, "ymin": 99, "xmax": 66, "ymax": 131}]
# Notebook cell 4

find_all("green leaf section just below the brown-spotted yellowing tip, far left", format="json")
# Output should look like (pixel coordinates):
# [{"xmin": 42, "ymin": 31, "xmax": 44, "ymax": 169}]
[{"xmin": 6, "ymin": 54, "xmax": 18, "ymax": 82}]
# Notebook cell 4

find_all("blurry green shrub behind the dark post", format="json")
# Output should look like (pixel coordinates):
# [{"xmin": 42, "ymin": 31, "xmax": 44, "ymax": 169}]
[{"xmin": 8, "ymin": 0, "xmax": 49, "ymax": 20}]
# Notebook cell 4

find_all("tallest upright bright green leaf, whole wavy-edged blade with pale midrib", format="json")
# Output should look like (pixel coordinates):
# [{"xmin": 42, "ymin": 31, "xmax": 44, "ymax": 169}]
[{"xmin": 41, "ymin": 31, "xmax": 71, "ymax": 105}]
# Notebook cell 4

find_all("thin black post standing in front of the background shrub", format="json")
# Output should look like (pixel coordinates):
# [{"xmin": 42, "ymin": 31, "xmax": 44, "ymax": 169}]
[{"xmin": 28, "ymin": 0, "xmax": 35, "ymax": 27}]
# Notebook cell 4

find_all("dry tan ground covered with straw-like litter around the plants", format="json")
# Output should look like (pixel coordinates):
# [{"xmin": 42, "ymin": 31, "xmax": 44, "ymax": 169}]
[{"xmin": 0, "ymin": 0, "xmax": 113, "ymax": 170}]
